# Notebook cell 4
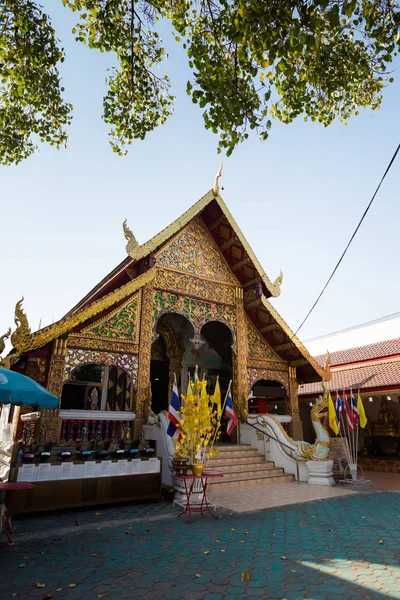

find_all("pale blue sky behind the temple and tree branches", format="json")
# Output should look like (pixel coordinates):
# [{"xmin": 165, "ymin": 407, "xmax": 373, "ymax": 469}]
[{"xmin": 0, "ymin": 0, "xmax": 400, "ymax": 350}]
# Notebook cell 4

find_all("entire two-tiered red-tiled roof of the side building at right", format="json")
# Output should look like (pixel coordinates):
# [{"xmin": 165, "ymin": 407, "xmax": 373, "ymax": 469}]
[{"xmin": 299, "ymin": 338, "xmax": 400, "ymax": 396}]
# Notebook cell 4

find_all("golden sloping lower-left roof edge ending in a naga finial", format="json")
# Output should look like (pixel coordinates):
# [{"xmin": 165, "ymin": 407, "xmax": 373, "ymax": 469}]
[{"xmin": 11, "ymin": 268, "xmax": 156, "ymax": 352}]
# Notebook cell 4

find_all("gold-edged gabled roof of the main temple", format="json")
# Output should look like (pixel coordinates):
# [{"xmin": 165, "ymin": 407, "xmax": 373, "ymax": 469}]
[{"xmin": 7, "ymin": 190, "xmax": 323, "ymax": 382}]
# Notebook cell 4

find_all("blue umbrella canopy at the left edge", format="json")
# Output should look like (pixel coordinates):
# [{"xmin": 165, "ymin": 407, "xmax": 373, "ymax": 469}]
[{"xmin": 0, "ymin": 367, "xmax": 59, "ymax": 408}]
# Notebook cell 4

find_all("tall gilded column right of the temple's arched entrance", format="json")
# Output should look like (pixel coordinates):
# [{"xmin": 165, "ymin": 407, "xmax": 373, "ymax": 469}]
[{"xmin": 232, "ymin": 287, "xmax": 248, "ymax": 417}]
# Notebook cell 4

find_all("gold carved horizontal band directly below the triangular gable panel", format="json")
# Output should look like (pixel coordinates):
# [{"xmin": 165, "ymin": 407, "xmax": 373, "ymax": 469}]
[{"xmin": 155, "ymin": 268, "xmax": 235, "ymax": 306}]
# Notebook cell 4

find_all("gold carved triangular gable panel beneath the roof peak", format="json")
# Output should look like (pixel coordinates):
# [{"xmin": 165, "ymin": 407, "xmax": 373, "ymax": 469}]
[{"xmin": 156, "ymin": 217, "xmax": 238, "ymax": 285}]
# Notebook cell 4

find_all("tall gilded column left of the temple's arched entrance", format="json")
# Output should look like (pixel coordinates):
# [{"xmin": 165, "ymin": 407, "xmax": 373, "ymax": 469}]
[{"xmin": 134, "ymin": 283, "xmax": 154, "ymax": 439}]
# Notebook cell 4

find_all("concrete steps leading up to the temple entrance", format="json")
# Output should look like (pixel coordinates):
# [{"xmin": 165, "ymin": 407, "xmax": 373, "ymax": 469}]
[{"xmin": 207, "ymin": 444, "xmax": 294, "ymax": 490}]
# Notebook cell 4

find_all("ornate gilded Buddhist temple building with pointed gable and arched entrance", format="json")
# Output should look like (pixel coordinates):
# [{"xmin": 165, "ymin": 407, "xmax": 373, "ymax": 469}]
[{"xmin": 2, "ymin": 180, "xmax": 330, "ymax": 496}]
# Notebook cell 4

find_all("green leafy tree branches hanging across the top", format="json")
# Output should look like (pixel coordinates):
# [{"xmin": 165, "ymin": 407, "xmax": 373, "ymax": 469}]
[{"xmin": 0, "ymin": 0, "xmax": 400, "ymax": 164}]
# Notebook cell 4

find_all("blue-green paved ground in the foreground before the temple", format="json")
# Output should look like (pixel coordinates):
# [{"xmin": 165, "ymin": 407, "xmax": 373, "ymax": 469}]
[{"xmin": 0, "ymin": 492, "xmax": 400, "ymax": 600}]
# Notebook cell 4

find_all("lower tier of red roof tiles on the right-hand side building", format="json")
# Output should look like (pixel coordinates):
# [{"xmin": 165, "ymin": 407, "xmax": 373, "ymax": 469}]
[{"xmin": 299, "ymin": 359, "xmax": 400, "ymax": 396}]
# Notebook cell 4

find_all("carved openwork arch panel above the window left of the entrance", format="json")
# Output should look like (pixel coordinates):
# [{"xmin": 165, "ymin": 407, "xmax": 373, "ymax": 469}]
[{"xmin": 63, "ymin": 348, "xmax": 138, "ymax": 386}]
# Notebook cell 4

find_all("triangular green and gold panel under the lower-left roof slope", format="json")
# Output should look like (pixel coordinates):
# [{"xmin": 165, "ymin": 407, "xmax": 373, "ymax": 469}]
[{"xmin": 81, "ymin": 294, "xmax": 139, "ymax": 343}]
